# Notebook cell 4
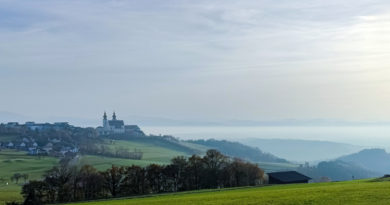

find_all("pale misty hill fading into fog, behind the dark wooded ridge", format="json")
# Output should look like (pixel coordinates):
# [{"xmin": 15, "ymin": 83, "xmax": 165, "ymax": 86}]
[{"xmin": 240, "ymin": 138, "xmax": 363, "ymax": 162}]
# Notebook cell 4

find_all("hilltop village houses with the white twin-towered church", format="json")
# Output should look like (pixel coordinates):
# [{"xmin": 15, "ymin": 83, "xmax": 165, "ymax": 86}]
[{"xmin": 0, "ymin": 112, "xmax": 145, "ymax": 157}]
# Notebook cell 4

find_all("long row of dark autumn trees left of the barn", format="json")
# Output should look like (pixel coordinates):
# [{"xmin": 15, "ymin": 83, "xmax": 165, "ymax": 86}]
[{"xmin": 22, "ymin": 150, "xmax": 264, "ymax": 204}]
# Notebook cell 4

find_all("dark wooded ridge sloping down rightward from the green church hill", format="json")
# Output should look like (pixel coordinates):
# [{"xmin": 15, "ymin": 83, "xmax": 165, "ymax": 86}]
[{"xmin": 187, "ymin": 139, "xmax": 288, "ymax": 163}]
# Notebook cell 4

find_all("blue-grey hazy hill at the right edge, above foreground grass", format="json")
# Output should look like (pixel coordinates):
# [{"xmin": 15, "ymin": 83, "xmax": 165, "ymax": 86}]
[{"xmin": 338, "ymin": 149, "xmax": 390, "ymax": 174}]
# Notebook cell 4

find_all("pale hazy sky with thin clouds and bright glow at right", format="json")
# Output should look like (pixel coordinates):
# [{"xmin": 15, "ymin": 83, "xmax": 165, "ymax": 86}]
[{"xmin": 0, "ymin": 0, "xmax": 390, "ymax": 124}]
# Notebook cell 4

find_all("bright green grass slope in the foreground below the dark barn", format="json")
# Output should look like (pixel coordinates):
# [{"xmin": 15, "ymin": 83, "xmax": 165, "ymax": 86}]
[{"xmin": 71, "ymin": 180, "xmax": 390, "ymax": 205}]
